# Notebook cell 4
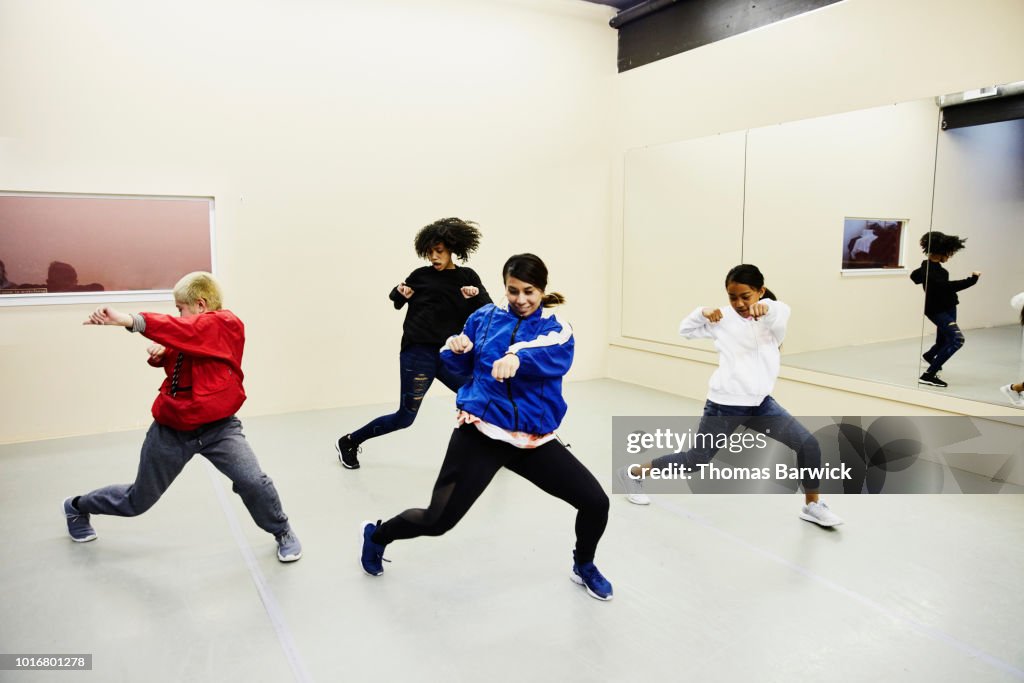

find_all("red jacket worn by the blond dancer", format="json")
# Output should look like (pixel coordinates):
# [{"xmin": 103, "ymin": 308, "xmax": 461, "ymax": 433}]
[{"xmin": 140, "ymin": 310, "xmax": 246, "ymax": 431}]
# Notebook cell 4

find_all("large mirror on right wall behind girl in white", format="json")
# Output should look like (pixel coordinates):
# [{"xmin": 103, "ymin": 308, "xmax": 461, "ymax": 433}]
[{"xmin": 622, "ymin": 87, "xmax": 1024, "ymax": 403}]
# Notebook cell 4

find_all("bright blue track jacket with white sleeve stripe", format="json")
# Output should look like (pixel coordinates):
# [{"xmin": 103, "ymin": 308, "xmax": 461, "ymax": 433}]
[{"xmin": 441, "ymin": 304, "xmax": 575, "ymax": 435}]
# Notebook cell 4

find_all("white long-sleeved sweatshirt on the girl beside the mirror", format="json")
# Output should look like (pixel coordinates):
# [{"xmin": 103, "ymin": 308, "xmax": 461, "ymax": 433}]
[{"xmin": 679, "ymin": 299, "xmax": 790, "ymax": 405}]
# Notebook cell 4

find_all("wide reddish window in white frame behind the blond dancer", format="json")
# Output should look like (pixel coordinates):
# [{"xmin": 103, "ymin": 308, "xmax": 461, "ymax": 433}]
[{"xmin": 0, "ymin": 191, "xmax": 214, "ymax": 306}]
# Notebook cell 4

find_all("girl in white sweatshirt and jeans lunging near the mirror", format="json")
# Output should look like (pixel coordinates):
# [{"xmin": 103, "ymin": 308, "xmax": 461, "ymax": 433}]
[{"xmin": 620, "ymin": 263, "xmax": 843, "ymax": 526}]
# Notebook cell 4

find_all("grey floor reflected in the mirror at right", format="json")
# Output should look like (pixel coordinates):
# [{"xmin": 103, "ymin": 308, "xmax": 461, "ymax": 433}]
[{"xmin": 782, "ymin": 325, "xmax": 1024, "ymax": 408}]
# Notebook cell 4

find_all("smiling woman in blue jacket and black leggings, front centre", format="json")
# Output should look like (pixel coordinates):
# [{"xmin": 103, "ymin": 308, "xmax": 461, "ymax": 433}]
[{"xmin": 360, "ymin": 254, "xmax": 612, "ymax": 600}]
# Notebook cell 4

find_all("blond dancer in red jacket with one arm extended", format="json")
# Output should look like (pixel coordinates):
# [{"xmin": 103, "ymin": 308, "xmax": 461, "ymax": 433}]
[{"xmin": 63, "ymin": 272, "xmax": 302, "ymax": 562}]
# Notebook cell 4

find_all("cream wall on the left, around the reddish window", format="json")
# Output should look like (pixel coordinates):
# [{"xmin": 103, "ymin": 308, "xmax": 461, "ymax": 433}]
[{"xmin": 0, "ymin": 0, "xmax": 615, "ymax": 442}]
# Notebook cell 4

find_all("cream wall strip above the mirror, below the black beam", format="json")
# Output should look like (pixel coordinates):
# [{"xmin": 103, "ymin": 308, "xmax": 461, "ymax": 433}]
[{"xmin": 615, "ymin": 0, "xmax": 1024, "ymax": 150}]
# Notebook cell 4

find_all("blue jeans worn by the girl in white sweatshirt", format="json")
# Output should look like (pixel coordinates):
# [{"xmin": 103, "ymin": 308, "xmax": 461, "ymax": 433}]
[{"xmin": 651, "ymin": 396, "xmax": 821, "ymax": 492}]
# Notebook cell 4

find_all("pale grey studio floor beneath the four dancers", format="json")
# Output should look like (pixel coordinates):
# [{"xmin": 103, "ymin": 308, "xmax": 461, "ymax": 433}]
[{"xmin": 0, "ymin": 380, "xmax": 1024, "ymax": 683}]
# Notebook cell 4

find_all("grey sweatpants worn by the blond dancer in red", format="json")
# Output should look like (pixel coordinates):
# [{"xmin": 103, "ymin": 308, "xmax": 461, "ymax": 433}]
[{"xmin": 78, "ymin": 416, "xmax": 288, "ymax": 536}]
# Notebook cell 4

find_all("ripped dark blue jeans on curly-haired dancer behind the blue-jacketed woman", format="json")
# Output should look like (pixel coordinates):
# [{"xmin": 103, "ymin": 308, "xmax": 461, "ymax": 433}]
[{"xmin": 352, "ymin": 344, "xmax": 469, "ymax": 443}]
